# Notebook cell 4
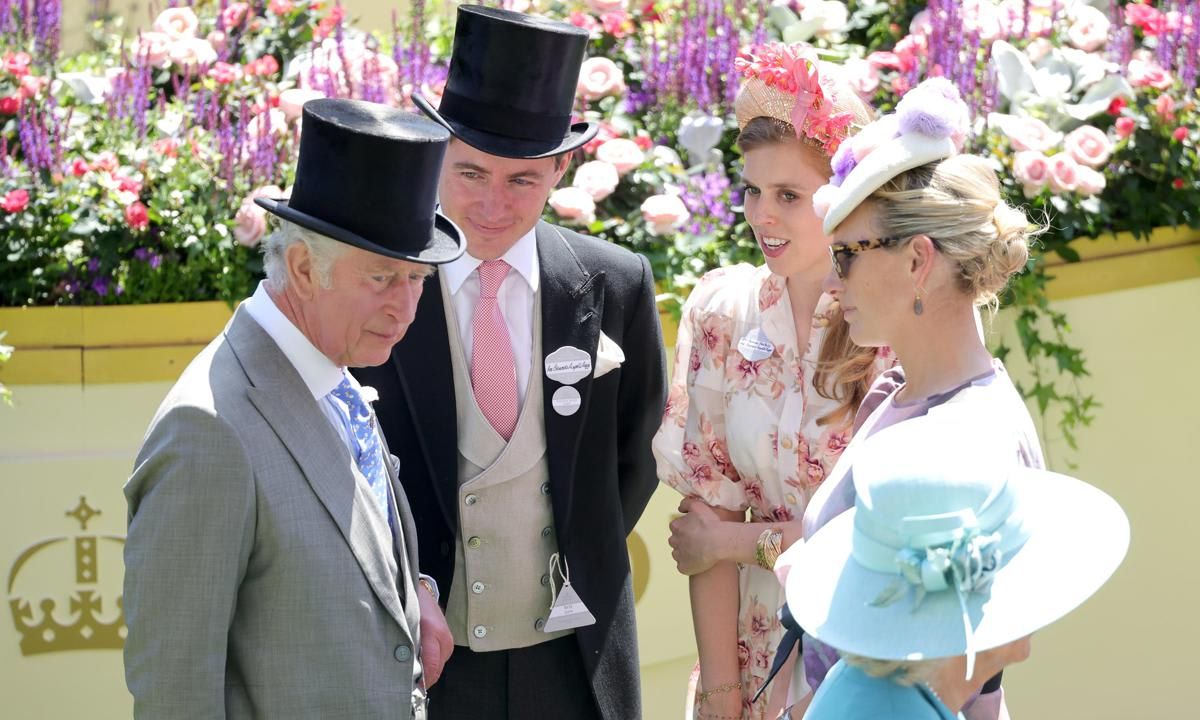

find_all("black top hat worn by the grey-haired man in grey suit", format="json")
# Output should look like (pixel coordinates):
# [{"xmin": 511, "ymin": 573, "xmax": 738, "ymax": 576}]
[{"xmin": 254, "ymin": 98, "xmax": 464, "ymax": 265}]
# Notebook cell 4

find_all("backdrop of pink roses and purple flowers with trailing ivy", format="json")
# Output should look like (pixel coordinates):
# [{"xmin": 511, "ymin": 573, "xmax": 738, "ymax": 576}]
[{"xmin": 7, "ymin": 0, "xmax": 1200, "ymax": 442}]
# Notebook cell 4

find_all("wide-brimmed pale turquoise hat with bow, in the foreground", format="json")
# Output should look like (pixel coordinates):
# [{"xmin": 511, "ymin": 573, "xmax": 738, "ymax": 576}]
[{"xmin": 787, "ymin": 418, "xmax": 1129, "ymax": 666}]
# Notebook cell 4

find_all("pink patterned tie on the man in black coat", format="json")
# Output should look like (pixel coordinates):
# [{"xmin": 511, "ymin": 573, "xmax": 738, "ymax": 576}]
[{"xmin": 470, "ymin": 260, "xmax": 517, "ymax": 440}]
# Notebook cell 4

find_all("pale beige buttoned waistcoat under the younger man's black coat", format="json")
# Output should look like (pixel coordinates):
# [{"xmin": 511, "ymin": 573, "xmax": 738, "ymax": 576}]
[{"xmin": 439, "ymin": 272, "xmax": 572, "ymax": 652}]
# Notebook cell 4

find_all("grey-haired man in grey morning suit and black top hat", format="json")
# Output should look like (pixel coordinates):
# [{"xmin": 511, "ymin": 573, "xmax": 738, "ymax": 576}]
[{"xmin": 125, "ymin": 100, "xmax": 462, "ymax": 720}]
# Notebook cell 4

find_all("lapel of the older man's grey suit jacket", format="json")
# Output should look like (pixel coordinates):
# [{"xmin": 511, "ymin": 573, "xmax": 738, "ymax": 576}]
[{"xmin": 226, "ymin": 308, "xmax": 409, "ymax": 632}]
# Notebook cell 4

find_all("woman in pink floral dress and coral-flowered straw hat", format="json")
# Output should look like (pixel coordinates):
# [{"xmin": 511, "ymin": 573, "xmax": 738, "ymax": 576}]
[{"xmin": 653, "ymin": 44, "xmax": 889, "ymax": 720}]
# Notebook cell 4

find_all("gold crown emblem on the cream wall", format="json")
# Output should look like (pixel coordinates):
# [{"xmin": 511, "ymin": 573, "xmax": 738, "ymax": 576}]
[{"xmin": 7, "ymin": 497, "xmax": 127, "ymax": 656}]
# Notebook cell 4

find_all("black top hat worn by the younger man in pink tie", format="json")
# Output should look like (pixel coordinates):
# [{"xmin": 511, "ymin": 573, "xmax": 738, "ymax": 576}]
[{"xmin": 413, "ymin": 5, "xmax": 599, "ymax": 158}]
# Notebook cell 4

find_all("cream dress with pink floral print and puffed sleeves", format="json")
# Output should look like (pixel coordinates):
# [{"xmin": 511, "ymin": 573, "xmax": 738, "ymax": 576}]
[{"xmin": 653, "ymin": 264, "xmax": 894, "ymax": 720}]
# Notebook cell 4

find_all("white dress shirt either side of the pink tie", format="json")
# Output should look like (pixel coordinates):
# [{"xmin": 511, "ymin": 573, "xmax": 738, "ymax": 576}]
[{"xmin": 440, "ymin": 230, "xmax": 539, "ymax": 407}]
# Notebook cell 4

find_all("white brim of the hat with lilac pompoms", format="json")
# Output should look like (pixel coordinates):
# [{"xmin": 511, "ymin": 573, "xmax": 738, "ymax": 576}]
[{"xmin": 823, "ymin": 133, "xmax": 958, "ymax": 235}]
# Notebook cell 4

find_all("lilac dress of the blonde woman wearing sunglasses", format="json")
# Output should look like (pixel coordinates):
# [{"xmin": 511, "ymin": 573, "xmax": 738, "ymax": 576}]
[{"xmin": 780, "ymin": 359, "xmax": 1045, "ymax": 690}]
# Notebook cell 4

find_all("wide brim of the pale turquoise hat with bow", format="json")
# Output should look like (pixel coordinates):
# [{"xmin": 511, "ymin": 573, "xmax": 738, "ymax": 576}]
[{"xmin": 787, "ymin": 468, "xmax": 1129, "ymax": 660}]
